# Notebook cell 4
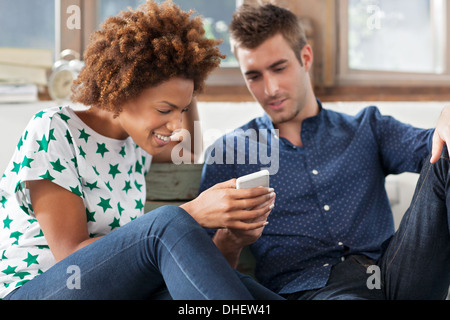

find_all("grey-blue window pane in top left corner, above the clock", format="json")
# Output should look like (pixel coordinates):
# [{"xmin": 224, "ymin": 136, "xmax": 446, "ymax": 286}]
[{"xmin": 0, "ymin": 0, "xmax": 55, "ymax": 50}]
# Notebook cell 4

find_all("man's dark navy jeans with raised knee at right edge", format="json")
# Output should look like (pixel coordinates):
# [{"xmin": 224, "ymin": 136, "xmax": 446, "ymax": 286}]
[{"xmin": 287, "ymin": 149, "xmax": 450, "ymax": 300}]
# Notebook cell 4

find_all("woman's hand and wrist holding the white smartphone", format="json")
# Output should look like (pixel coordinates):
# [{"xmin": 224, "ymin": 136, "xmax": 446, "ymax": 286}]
[{"xmin": 181, "ymin": 179, "xmax": 275, "ymax": 231}]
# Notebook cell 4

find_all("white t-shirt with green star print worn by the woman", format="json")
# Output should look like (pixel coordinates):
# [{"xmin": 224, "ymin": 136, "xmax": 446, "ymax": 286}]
[{"xmin": 0, "ymin": 107, "xmax": 151, "ymax": 299}]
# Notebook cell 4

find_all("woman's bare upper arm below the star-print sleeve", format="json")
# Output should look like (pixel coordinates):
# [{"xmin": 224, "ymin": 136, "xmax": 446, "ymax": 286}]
[{"xmin": 27, "ymin": 180, "xmax": 99, "ymax": 261}]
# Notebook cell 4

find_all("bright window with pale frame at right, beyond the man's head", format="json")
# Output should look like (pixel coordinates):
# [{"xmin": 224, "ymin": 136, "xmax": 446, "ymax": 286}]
[{"xmin": 338, "ymin": 0, "xmax": 450, "ymax": 85}]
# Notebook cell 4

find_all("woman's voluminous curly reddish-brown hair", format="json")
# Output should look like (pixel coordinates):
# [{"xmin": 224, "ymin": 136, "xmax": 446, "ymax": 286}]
[{"xmin": 72, "ymin": 0, "xmax": 225, "ymax": 115}]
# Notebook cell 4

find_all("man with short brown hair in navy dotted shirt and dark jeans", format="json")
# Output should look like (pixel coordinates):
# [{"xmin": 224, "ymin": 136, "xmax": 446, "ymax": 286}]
[{"xmin": 201, "ymin": 5, "xmax": 450, "ymax": 299}]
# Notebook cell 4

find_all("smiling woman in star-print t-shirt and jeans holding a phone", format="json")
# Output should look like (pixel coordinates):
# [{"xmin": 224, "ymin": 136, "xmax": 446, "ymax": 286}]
[{"xmin": 0, "ymin": 1, "xmax": 276, "ymax": 299}]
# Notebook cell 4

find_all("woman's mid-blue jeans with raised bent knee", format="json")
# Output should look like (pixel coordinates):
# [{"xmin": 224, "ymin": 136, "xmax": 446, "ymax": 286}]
[{"xmin": 5, "ymin": 206, "xmax": 279, "ymax": 300}]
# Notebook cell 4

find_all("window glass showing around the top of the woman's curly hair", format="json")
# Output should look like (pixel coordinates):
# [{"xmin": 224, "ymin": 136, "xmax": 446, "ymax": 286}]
[{"xmin": 97, "ymin": 0, "xmax": 239, "ymax": 67}]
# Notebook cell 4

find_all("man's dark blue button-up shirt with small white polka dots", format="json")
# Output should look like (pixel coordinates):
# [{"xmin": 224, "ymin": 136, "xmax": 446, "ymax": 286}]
[{"xmin": 200, "ymin": 101, "xmax": 434, "ymax": 294}]
